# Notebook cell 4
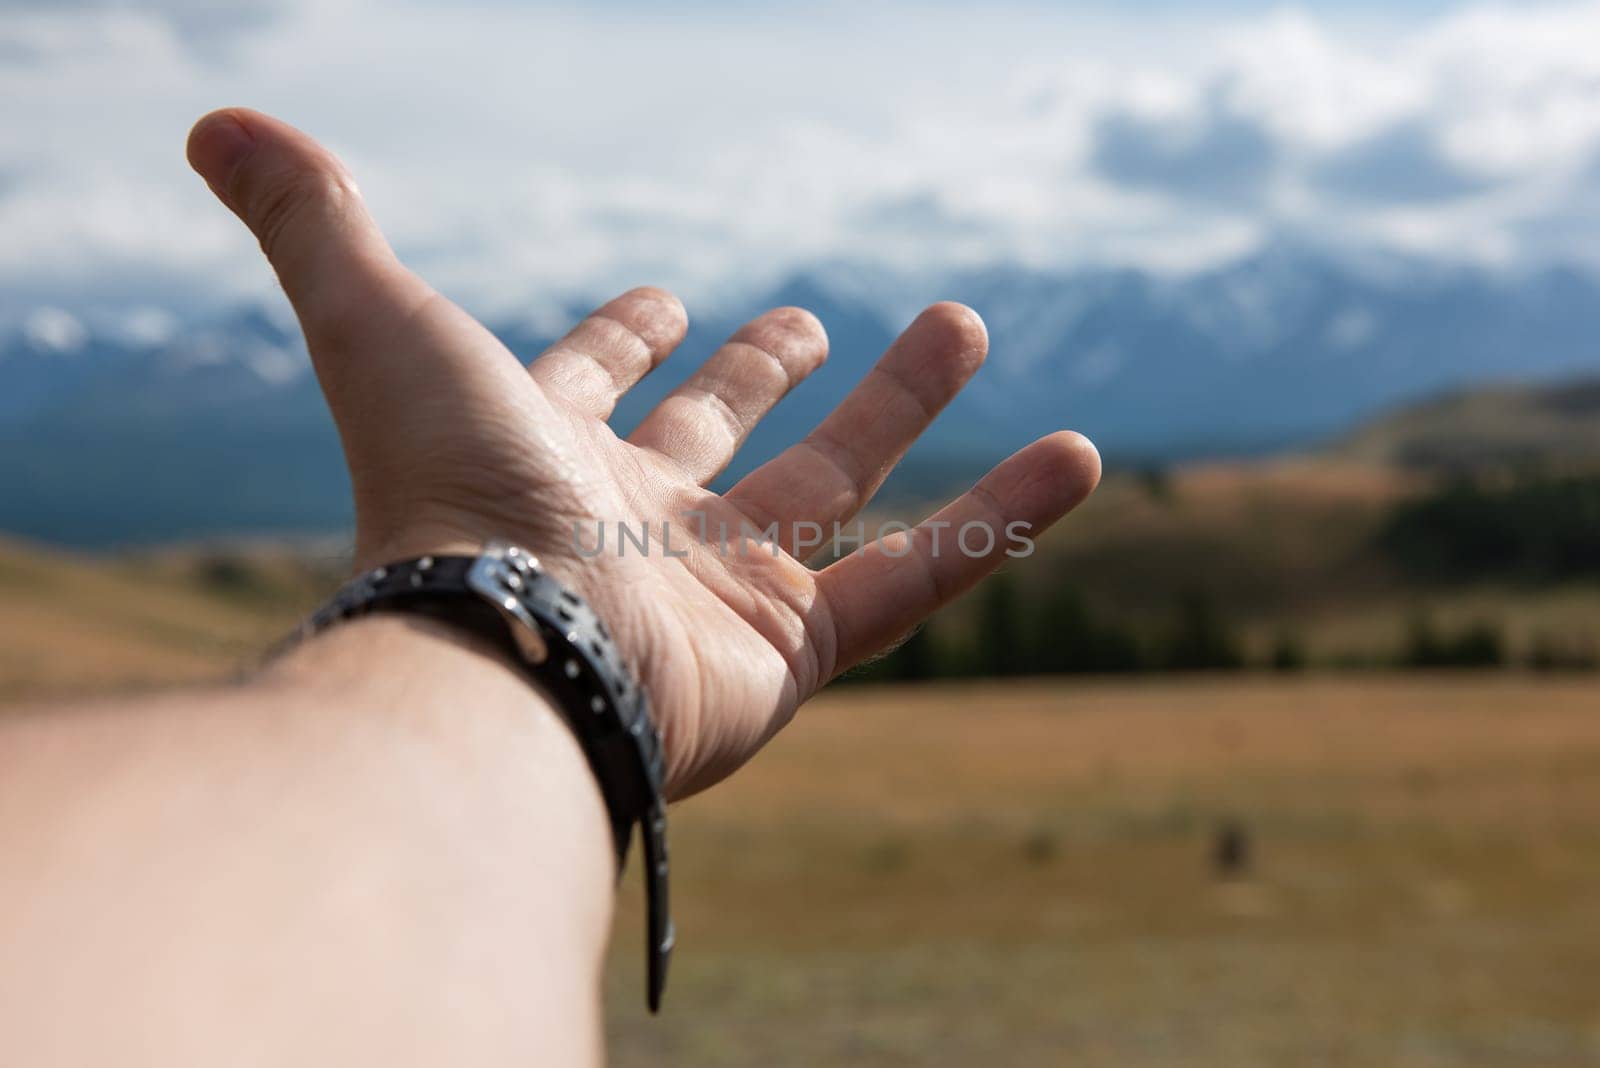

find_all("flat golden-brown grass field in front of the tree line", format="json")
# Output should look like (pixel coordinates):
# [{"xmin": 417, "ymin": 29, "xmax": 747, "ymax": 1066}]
[{"xmin": 611, "ymin": 675, "xmax": 1600, "ymax": 1068}]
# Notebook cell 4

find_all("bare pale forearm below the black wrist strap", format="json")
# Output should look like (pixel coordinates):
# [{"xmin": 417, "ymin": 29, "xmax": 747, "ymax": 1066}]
[{"xmin": 0, "ymin": 617, "xmax": 614, "ymax": 1065}]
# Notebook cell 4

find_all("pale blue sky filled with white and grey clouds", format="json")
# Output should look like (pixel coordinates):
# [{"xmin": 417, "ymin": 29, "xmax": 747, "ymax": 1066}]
[{"xmin": 0, "ymin": 0, "xmax": 1600, "ymax": 310}]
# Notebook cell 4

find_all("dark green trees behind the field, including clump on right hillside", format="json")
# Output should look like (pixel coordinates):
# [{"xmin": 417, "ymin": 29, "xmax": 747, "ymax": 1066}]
[{"xmin": 853, "ymin": 476, "xmax": 1600, "ymax": 681}]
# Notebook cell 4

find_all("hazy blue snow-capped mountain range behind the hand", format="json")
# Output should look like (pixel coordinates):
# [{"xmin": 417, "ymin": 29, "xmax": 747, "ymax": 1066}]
[{"xmin": 0, "ymin": 246, "xmax": 1600, "ymax": 545}]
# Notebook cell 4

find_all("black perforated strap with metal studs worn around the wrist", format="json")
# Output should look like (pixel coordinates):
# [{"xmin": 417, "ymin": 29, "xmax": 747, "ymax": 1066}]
[{"xmin": 294, "ymin": 542, "xmax": 674, "ymax": 1012}]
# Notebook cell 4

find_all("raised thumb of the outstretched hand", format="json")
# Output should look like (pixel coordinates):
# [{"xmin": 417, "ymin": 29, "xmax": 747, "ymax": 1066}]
[{"xmin": 189, "ymin": 107, "xmax": 432, "ymax": 357}]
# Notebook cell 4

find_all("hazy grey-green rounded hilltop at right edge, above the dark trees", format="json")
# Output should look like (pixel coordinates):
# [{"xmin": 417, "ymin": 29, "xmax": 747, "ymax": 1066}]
[{"xmin": 1331, "ymin": 377, "xmax": 1600, "ymax": 473}]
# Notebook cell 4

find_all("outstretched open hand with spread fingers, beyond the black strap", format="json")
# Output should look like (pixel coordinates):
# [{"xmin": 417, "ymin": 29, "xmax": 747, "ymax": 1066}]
[{"xmin": 189, "ymin": 109, "xmax": 1099, "ymax": 796}]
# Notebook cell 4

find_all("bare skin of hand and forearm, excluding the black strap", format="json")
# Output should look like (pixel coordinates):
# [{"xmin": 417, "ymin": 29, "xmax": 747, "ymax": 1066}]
[{"xmin": 0, "ymin": 109, "xmax": 1099, "ymax": 1065}]
